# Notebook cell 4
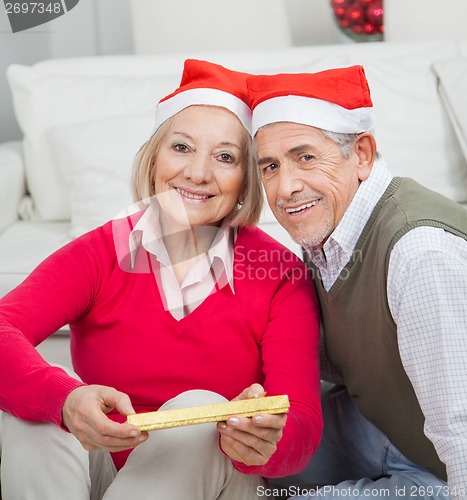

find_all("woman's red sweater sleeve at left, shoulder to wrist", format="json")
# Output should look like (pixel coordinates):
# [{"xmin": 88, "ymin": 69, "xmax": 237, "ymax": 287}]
[{"xmin": 0, "ymin": 228, "xmax": 108, "ymax": 425}]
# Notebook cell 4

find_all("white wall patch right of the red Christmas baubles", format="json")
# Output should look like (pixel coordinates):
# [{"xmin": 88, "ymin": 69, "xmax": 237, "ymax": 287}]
[{"xmin": 384, "ymin": 0, "xmax": 467, "ymax": 42}]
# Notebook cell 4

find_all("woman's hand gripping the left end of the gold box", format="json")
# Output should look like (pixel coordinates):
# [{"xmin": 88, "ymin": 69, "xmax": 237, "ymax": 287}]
[{"xmin": 62, "ymin": 385, "xmax": 148, "ymax": 451}]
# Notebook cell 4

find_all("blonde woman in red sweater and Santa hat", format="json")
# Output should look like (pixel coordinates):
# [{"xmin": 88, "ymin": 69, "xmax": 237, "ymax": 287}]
[{"xmin": 0, "ymin": 60, "xmax": 321, "ymax": 500}]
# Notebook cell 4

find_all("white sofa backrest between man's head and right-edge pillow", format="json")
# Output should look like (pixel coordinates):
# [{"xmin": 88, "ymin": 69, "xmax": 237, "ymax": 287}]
[{"xmin": 349, "ymin": 42, "xmax": 467, "ymax": 202}]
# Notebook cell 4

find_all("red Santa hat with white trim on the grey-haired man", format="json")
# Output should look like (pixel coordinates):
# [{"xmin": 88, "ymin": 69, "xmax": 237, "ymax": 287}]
[{"xmin": 247, "ymin": 66, "xmax": 374, "ymax": 135}]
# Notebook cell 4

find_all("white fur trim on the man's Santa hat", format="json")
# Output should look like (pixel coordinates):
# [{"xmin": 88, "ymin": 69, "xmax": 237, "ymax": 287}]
[{"xmin": 252, "ymin": 95, "xmax": 374, "ymax": 135}]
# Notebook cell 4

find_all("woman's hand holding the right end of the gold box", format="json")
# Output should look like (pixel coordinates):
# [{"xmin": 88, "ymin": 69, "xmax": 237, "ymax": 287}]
[{"xmin": 217, "ymin": 384, "xmax": 287, "ymax": 465}]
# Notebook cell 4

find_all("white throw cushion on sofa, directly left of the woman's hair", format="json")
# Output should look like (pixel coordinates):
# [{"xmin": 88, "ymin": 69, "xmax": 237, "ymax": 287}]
[{"xmin": 51, "ymin": 111, "xmax": 154, "ymax": 238}]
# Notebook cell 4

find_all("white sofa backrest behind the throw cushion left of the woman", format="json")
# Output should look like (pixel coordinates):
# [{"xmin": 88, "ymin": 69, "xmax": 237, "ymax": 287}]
[{"xmin": 7, "ymin": 65, "xmax": 180, "ymax": 220}]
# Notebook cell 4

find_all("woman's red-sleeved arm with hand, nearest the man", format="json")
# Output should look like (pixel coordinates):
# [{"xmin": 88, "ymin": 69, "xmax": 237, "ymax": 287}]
[{"xmin": 220, "ymin": 262, "xmax": 322, "ymax": 477}]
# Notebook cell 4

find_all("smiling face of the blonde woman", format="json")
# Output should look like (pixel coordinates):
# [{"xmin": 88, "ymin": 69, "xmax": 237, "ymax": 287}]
[{"xmin": 154, "ymin": 106, "xmax": 246, "ymax": 226}]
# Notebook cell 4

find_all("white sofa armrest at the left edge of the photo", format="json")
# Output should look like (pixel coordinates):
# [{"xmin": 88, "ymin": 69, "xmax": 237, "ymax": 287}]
[{"xmin": 0, "ymin": 141, "xmax": 26, "ymax": 233}]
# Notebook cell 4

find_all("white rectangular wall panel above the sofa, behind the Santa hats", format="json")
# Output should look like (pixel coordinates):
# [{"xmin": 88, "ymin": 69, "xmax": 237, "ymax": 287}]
[{"xmin": 130, "ymin": 0, "xmax": 292, "ymax": 54}]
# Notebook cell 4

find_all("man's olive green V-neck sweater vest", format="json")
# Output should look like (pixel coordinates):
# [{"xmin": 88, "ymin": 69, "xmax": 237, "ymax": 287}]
[{"xmin": 307, "ymin": 178, "xmax": 467, "ymax": 479}]
